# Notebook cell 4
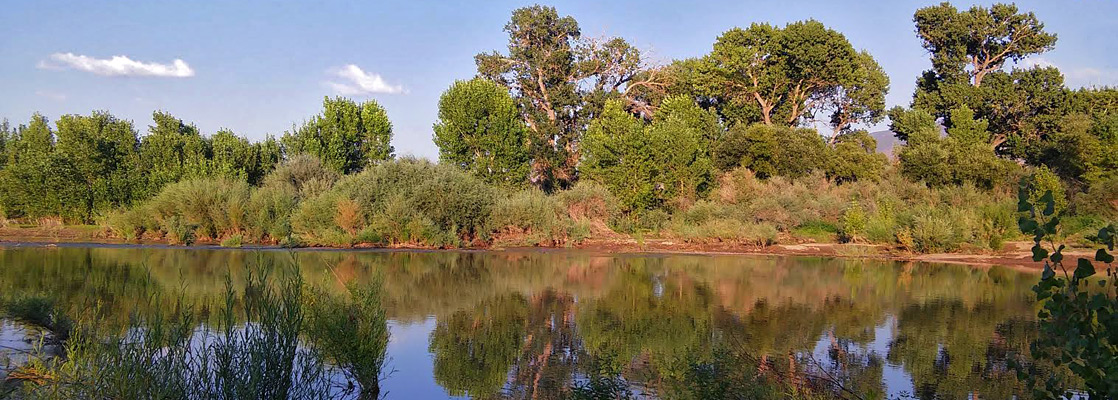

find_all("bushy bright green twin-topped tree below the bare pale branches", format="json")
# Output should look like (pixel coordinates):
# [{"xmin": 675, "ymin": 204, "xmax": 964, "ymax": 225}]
[{"xmin": 581, "ymin": 97, "xmax": 711, "ymax": 210}]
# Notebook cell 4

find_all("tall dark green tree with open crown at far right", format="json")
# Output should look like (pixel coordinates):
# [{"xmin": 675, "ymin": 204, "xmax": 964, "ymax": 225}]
[{"xmin": 912, "ymin": 2, "xmax": 1068, "ymax": 159}]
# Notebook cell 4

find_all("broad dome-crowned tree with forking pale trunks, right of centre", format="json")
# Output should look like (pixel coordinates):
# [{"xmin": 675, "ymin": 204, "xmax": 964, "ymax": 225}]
[{"xmin": 699, "ymin": 20, "xmax": 867, "ymax": 126}]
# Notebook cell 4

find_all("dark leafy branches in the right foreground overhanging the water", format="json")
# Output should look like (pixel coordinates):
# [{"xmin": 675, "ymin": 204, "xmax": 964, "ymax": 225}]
[{"xmin": 1017, "ymin": 184, "xmax": 1118, "ymax": 399}]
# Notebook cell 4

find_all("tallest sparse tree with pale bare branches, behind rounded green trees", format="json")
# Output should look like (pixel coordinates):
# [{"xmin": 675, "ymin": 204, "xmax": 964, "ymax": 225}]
[{"xmin": 474, "ymin": 6, "xmax": 655, "ymax": 190}]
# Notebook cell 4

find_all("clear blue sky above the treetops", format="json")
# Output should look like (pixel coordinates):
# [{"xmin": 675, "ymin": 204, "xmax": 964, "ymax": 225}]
[{"xmin": 0, "ymin": 0, "xmax": 1118, "ymax": 158}]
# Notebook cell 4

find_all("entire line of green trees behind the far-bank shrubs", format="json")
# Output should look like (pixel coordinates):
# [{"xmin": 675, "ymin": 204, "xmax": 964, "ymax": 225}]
[{"xmin": 0, "ymin": 2, "xmax": 1118, "ymax": 226}]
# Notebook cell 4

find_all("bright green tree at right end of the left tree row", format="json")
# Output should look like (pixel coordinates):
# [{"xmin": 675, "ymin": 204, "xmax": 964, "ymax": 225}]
[{"xmin": 282, "ymin": 97, "xmax": 395, "ymax": 173}]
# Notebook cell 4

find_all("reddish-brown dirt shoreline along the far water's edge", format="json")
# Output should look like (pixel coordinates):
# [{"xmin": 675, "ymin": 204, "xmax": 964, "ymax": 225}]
[{"xmin": 0, "ymin": 227, "xmax": 1064, "ymax": 270}]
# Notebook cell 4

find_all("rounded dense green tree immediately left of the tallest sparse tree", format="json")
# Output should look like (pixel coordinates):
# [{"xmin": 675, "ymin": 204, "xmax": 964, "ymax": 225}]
[{"xmin": 434, "ymin": 78, "xmax": 531, "ymax": 185}]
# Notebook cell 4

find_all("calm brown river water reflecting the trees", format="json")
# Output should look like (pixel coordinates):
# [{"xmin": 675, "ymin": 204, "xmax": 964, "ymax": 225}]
[{"xmin": 0, "ymin": 247, "xmax": 1038, "ymax": 399}]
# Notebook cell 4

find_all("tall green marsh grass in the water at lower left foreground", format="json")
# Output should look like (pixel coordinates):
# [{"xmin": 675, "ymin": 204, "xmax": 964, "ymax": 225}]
[{"xmin": 6, "ymin": 257, "xmax": 388, "ymax": 399}]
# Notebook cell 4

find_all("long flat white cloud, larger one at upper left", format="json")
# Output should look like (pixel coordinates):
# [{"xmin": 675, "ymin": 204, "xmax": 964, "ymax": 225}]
[{"xmin": 39, "ymin": 53, "xmax": 195, "ymax": 78}]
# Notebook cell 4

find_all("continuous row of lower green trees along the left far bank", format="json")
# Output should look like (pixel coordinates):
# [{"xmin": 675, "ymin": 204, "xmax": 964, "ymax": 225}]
[{"xmin": 0, "ymin": 98, "xmax": 394, "ymax": 222}]
